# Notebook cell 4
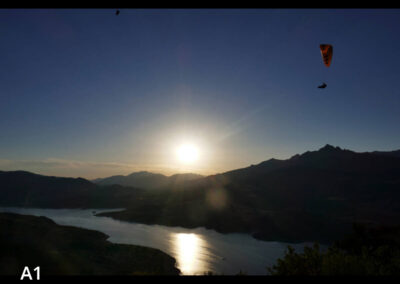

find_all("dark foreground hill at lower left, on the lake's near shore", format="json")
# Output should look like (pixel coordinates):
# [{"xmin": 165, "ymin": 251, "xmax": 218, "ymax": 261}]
[{"xmin": 0, "ymin": 213, "xmax": 179, "ymax": 277}]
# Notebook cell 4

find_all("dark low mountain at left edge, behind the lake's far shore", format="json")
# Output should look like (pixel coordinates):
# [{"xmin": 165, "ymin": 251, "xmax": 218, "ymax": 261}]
[{"xmin": 0, "ymin": 171, "xmax": 143, "ymax": 208}]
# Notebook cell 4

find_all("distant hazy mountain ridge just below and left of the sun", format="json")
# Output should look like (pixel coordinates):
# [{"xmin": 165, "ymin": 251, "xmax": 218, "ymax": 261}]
[{"xmin": 93, "ymin": 171, "xmax": 203, "ymax": 189}]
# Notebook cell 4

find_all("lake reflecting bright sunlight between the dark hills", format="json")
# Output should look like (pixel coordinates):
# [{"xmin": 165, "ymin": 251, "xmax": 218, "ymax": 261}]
[{"xmin": 0, "ymin": 207, "xmax": 311, "ymax": 275}]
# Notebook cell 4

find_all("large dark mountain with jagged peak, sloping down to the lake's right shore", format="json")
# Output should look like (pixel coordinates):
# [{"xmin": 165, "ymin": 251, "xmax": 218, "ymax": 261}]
[{"xmin": 102, "ymin": 145, "xmax": 400, "ymax": 243}]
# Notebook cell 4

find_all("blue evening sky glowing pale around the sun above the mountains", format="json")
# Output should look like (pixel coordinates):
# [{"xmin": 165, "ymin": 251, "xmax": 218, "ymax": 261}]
[{"xmin": 0, "ymin": 9, "xmax": 400, "ymax": 178}]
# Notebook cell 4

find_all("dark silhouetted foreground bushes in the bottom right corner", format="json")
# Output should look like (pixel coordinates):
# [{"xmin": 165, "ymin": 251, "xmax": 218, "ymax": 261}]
[{"xmin": 267, "ymin": 225, "xmax": 400, "ymax": 275}]
